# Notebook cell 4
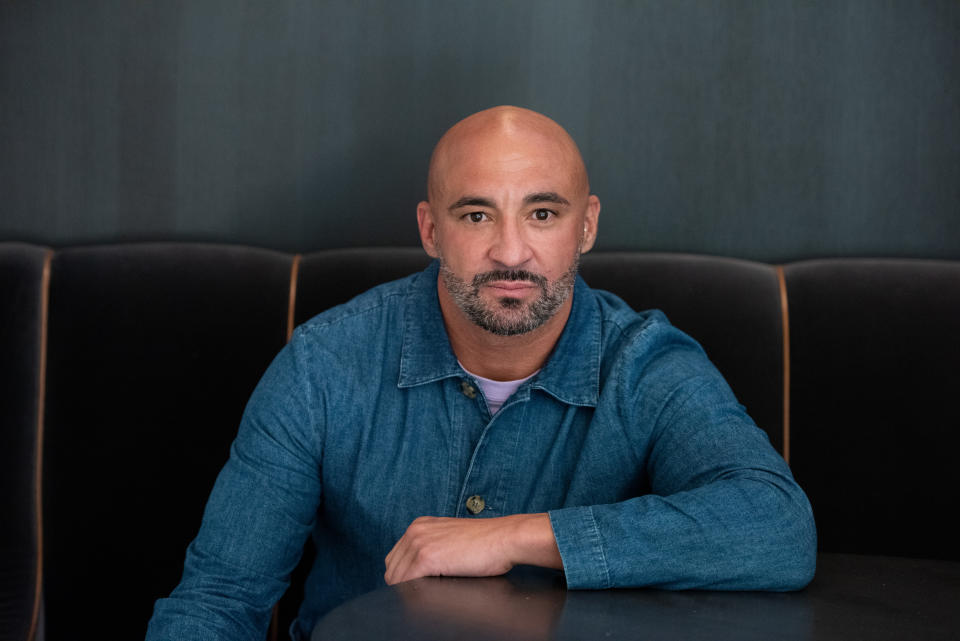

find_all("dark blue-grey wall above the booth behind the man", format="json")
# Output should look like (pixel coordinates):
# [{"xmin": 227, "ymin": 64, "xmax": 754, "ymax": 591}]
[{"xmin": 0, "ymin": 0, "xmax": 960, "ymax": 261}]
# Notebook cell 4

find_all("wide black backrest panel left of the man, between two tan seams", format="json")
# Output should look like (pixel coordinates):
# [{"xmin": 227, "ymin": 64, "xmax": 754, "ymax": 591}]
[{"xmin": 44, "ymin": 244, "xmax": 291, "ymax": 641}]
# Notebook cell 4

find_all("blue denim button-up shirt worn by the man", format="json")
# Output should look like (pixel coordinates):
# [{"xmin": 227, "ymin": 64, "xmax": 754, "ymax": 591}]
[{"xmin": 147, "ymin": 263, "xmax": 816, "ymax": 641}]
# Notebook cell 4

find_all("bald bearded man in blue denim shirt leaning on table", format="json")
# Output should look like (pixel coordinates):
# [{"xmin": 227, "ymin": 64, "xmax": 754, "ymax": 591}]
[{"xmin": 148, "ymin": 107, "xmax": 816, "ymax": 640}]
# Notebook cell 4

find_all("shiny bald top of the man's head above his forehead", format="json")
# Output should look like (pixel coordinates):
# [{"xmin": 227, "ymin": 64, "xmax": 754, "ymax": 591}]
[{"xmin": 427, "ymin": 106, "xmax": 590, "ymax": 203}]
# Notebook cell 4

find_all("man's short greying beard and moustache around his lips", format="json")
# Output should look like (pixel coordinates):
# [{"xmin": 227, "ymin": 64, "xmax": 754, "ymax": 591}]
[{"xmin": 440, "ymin": 247, "xmax": 580, "ymax": 336}]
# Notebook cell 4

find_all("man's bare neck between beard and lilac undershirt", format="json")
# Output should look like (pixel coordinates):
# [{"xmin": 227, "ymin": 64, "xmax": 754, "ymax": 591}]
[{"xmin": 437, "ymin": 274, "xmax": 573, "ymax": 381}]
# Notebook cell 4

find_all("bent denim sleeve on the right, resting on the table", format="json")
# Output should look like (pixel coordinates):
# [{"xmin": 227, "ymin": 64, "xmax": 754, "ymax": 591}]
[{"xmin": 550, "ymin": 324, "xmax": 816, "ymax": 590}]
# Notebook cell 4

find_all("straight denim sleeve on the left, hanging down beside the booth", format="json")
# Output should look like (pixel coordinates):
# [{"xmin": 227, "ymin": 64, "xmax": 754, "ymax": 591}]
[{"xmin": 146, "ymin": 334, "xmax": 322, "ymax": 641}]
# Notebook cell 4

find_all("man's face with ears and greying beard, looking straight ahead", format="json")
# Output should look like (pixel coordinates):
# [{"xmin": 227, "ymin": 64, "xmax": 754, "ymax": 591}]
[{"xmin": 420, "ymin": 121, "xmax": 599, "ymax": 336}]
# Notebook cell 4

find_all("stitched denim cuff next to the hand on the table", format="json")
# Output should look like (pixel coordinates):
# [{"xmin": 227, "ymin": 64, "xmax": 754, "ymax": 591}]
[{"xmin": 548, "ymin": 507, "xmax": 611, "ymax": 590}]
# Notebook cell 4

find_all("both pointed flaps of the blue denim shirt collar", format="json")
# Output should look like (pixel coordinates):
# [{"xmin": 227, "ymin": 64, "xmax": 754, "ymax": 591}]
[{"xmin": 398, "ymin": 261, "xmax": 601, "ymax": 407}]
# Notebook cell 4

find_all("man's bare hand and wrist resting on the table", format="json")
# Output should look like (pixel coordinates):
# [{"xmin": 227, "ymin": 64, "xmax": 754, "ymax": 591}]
[{"xmin": 384, "ymin": 513, "xmax": 563, "ymax": 585}]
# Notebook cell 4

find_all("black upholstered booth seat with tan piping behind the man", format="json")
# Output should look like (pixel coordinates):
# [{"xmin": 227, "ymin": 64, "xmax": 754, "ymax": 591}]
[{"xmin": 0, "ymin": 243, "xmax": 960, "ymax": 641}]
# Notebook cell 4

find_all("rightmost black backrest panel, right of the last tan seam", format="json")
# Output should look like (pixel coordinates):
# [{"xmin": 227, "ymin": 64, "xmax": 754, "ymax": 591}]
[{"xmin": 785, "ymin": 259, "xmax": 960, "ymax": 560}]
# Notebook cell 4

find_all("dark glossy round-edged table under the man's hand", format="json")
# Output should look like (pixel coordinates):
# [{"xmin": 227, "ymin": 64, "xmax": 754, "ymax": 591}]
[{"xmin": 311, "ymin": 554, "xmax": 960, "ymax": 641}]
